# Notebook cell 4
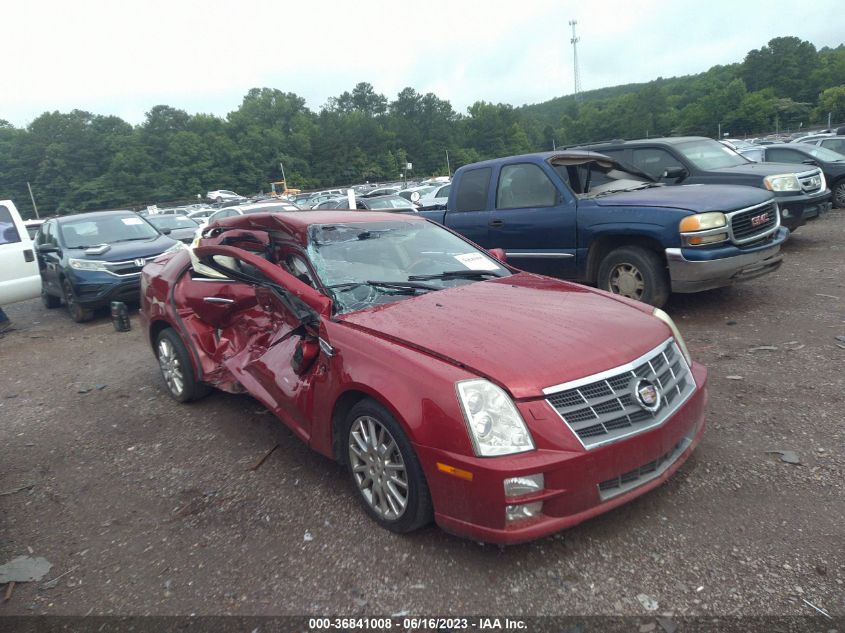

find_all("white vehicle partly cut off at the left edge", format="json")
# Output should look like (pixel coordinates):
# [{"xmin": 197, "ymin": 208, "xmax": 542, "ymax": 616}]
[{"xmin": 0, "ymin": 200, "xmax": 41, "ymax": 306}]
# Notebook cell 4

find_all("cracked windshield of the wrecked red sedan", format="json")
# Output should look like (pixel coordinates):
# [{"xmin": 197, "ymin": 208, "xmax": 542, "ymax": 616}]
[{"xmin": 308, "ymin": 220, "xmax": 510, "ymax": 314}]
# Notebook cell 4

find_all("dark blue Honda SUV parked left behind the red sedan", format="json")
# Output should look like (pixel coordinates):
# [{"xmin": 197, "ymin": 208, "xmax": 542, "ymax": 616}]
[{"xmin": 35, "ymin": 211, "xmax": 185, "ymax": 323}]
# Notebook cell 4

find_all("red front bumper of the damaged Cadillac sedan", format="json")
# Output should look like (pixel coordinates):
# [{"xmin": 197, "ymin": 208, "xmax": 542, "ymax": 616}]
[{"xmin": 414, "ymin": 363, "xmax": 708, "ymax": 544}]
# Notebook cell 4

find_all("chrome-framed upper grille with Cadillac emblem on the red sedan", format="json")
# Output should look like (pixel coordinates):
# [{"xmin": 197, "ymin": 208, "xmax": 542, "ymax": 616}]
[{"xmin": 543, "ymin": 339, "xmax": 695, "ymax": 449}]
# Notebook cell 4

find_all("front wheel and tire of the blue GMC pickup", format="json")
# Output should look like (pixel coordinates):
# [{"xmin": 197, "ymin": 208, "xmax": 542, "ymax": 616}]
[{"xmin": 597, "ymin": 246, "xmax": 669, "ymax": 308}]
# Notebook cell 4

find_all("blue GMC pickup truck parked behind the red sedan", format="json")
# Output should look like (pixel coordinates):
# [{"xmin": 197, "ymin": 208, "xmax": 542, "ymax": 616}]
[{"xmin": 420, "ymin": 150, "xmax": 789, "ymax": 306}]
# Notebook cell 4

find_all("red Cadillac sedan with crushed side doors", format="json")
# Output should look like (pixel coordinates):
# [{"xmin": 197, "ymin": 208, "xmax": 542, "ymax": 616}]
[{"xmin": 141, "ymin": 211, "xmax": 707, "ymax": 544}]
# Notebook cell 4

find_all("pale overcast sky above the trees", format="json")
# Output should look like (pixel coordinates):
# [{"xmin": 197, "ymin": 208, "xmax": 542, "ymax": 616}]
[{"xmin": 0, "ymin": 0, "xmax": 845, "ymax": 126}]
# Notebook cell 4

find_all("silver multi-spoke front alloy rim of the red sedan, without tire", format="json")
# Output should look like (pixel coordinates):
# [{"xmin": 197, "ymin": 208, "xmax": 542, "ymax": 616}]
[{"xmin": 349, "ymin": 416, "xmax": 409, "ymax": 521}]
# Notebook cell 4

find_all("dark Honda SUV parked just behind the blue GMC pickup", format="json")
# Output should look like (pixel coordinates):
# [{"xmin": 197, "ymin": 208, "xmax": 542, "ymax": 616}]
[{"xmin": 581, "ymin": 136, "xmax": 831, "ymax": 230}]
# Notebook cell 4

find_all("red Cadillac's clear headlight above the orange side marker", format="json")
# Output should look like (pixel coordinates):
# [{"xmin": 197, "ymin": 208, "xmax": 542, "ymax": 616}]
[{"xmin": 455, "ymin": 378, "xmax": 534, "ymax": 457}]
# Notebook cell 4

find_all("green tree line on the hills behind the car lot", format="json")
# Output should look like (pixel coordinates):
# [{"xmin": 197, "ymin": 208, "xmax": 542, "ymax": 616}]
[{"xmin": 0, "ymin": 37, "xmax": 845, "ymax": 216}]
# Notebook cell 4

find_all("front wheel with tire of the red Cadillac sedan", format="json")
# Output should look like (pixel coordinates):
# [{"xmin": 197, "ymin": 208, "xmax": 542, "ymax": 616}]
[{"xmin": 344, "ymin": 400, "xmax": 432, "ymax": 533}]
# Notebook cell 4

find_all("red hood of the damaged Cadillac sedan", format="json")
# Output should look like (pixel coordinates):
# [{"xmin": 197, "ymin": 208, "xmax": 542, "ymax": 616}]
[{"xmin": 332, "ymin": 273, "xmax": 671, "ymax": 398}]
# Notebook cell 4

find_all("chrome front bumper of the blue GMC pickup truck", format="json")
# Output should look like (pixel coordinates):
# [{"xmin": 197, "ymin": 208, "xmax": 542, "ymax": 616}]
[{"xmin": 666, "ymin": 227, "xmax": 789, "ymax": 292}]
